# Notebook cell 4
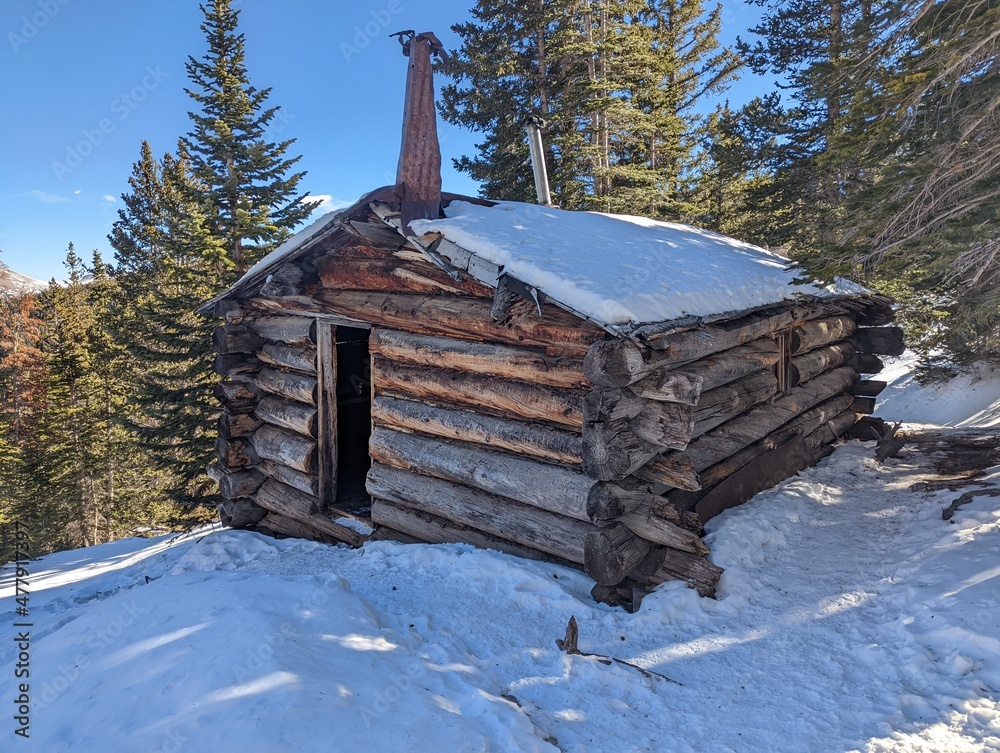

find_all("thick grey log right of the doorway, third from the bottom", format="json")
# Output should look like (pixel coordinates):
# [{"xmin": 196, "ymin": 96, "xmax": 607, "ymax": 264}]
[{"xmin": 369, "ymin": 428, "xmax": 594, "ymax": 522}]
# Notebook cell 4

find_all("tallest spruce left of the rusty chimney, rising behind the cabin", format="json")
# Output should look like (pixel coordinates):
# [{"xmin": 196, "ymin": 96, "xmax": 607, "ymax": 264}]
[{"xmin": 184, "ymin": 0, "xmax": 317, "ymax": 276}]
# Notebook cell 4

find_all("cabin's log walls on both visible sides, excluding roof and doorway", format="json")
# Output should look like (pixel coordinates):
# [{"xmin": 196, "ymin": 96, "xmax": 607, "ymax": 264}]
[{"xmin": 203, "ymin": 222, "xmax": 902, "ymax": 605}]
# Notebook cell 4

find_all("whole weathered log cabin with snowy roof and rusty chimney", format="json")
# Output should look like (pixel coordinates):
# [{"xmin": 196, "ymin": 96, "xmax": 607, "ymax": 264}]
[{"xmin": 195, "ymin": 34, "xmax": 903, "ymax": 607}]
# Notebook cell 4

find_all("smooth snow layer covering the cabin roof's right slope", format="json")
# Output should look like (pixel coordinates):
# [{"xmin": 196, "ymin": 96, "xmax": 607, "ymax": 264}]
[{"xmin": 411, "ymin": 201, "xmax": 824, "ymax": 324}]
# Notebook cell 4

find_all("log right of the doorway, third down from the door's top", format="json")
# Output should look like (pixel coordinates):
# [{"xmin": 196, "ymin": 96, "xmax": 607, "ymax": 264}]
[{"xmin": 372, "ymin": 396, "xmax": 583, "ymax": 465}]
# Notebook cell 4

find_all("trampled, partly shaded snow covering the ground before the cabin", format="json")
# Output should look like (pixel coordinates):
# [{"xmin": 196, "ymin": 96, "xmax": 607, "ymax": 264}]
[{"xmin": 0, "ymin": 434, "xmax": 1000, "ymax": 753}]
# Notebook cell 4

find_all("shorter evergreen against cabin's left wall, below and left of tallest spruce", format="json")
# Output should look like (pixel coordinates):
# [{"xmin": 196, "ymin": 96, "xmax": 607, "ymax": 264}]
[{"xmin": 110, "ymin": 144, "xmax": 225, "ymax": 503}]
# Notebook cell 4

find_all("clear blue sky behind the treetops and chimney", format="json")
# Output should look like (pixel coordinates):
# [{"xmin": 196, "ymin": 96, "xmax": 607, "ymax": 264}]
[{"xmin": 0, "ymin": 0, "xmax": 760, "ymax": 279}]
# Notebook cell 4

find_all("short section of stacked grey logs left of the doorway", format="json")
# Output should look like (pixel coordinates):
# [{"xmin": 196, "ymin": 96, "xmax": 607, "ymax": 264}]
[{"xmin": 210, "ymin": 308, "xmax": 363, "ymax": 546}]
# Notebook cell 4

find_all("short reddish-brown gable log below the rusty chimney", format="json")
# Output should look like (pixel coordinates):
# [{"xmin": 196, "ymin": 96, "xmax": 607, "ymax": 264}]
[{"xmin": 316, "ymin": 256, "xmax": 493, "ymax": 298}]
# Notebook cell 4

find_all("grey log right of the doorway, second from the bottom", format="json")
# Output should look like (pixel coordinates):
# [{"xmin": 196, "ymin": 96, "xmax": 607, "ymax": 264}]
[{"xmin": 368, "ymin": 463, "xmax": 597, "ymax": 564}]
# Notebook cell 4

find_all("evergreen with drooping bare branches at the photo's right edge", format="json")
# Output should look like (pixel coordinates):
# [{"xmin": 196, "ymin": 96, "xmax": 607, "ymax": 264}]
[{"xmin": 829, "ymin": 0, "xmax": 1000, "ymax": 363}]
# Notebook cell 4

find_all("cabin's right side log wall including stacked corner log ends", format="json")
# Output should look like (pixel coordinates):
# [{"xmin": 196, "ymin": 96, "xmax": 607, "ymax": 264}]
[{"xmin": 582, "ymin": 299, "xmax": 902, "ymax": 602}]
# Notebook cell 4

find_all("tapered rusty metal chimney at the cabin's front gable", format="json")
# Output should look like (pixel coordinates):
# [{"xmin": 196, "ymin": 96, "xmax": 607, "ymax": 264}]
[{"xmin": 392, "ymin": 30, "xmax": 447, "ymax": 234}]
